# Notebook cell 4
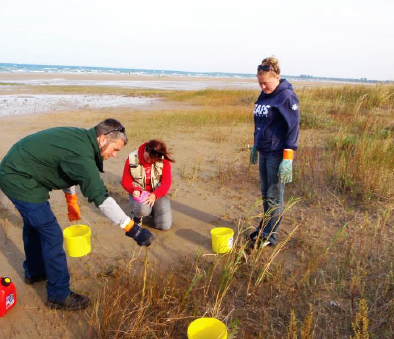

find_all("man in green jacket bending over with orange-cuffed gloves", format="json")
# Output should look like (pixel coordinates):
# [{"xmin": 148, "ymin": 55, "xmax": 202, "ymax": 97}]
[{"xmin": 0, "ymin": 119, "xmax": 154, "ymax": 310}]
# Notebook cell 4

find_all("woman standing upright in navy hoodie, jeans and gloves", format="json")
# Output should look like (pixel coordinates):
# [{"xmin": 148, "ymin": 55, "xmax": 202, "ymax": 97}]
[{"xmin": 250, "ymin": 57, "xmax": 300, "ymax": 246}]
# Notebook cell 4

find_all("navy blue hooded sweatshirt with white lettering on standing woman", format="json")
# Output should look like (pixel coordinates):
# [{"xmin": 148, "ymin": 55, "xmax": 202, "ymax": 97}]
[{"xmin": 253, "ymin": 79, "xmax": 300, "ymax": 155}]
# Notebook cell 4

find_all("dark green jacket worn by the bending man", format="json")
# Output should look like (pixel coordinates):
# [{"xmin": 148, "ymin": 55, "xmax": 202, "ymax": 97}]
[{"xmin": 0, "ymin": 127, "xmax": 108, "ymax": 206}]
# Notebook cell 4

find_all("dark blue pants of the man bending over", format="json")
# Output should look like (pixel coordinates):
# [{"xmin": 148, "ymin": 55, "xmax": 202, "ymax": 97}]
[{"xmin": 11, "ymin": 199, "xmax": 70, "ymax": 300}]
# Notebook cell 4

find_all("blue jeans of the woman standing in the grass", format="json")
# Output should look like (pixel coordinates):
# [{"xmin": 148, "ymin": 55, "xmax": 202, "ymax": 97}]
[{"xmin": 258, "ymin": 152, "xmax": 285, "ymax": 245}]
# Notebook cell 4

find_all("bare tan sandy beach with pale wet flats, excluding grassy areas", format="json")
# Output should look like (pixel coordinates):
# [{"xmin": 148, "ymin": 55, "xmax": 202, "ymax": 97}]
[{"xmin": 0, "ymin": 74, "xmax": 264, "ymax": 338}]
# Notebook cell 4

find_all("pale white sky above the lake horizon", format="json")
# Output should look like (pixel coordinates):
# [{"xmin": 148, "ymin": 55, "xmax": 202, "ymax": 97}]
[{"xmin": 0, "ymin": 0, "xmax": 394, "ymax": 81}]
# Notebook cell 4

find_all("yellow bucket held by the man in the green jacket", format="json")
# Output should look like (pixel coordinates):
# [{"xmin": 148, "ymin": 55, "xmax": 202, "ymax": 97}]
[{"xmin": 63, "ymin": 225, "xmax": 92, "ymax": 257}]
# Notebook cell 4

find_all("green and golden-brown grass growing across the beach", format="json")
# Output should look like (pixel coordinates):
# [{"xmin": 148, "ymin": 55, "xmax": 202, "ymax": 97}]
[{"xmin": 40, "ymin": 85, "xmax": 394, "ymax": 339}]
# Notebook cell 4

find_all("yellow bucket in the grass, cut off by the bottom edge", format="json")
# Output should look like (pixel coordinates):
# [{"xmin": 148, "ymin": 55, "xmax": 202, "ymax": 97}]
[{"xmin": 187, "ymin": 318, "xmax": 227, "ymax": 339}]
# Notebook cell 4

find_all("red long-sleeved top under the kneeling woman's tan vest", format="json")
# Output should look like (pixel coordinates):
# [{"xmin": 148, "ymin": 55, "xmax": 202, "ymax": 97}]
[{"xmin": 122, "ymin": 143, "xmax": 172, "ymax": 199}]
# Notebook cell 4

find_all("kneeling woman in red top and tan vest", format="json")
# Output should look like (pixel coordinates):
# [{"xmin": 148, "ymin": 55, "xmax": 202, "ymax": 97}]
[{"xmin": 122, "ymin": 140, "xmax": 175, "ymax": 231}]
